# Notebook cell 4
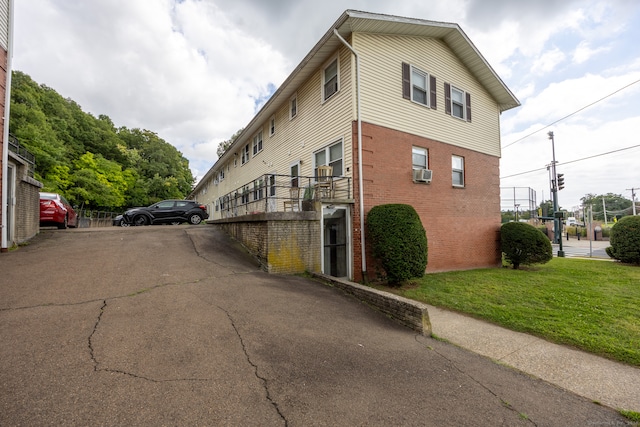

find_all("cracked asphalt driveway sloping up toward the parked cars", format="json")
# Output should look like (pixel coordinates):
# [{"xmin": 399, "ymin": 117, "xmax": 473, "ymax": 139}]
[{"xmin": 0, "ymin": 225, "xmax": 624, "ymax": 426}]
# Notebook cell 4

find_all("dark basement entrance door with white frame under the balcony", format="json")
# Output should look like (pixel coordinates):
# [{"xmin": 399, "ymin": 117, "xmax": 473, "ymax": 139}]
[{"xmin": 322, "ymin": 205, "xmax": 351, "ymax": 277}]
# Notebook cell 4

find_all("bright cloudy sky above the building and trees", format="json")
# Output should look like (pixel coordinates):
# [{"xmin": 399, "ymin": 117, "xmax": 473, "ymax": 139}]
[{"xmin": 13, "ymin": 0, "xmax": 640, "ymax": 209}]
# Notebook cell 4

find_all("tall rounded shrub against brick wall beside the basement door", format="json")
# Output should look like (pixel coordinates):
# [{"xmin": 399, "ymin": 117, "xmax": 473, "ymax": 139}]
[{"xmin": 367, "ymin": 204, "xmax": 427, "ymax": 285}]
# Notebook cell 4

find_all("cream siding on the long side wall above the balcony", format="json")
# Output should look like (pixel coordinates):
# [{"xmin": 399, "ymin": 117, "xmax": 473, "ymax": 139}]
[{"xmin": 195, "ymin": 48, "xmax": 355, "ymax": 219}]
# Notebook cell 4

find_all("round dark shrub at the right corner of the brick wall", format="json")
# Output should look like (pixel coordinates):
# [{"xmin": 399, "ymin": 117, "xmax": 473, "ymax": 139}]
[{"xmin": 500, "ymin": 222, "xmax": 553, "ymax": 269}]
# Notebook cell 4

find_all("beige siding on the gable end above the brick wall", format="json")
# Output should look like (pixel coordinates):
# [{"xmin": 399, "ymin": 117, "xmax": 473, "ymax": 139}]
[{"xmin": 353, "ymin": 33, "xmax": 500, "ymax": 156}]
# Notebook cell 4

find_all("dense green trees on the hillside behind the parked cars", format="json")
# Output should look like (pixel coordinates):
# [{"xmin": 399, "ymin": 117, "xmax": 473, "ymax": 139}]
[{"xmin": 9, "ymin": 71, "xmax": 194, "ymax": 210}]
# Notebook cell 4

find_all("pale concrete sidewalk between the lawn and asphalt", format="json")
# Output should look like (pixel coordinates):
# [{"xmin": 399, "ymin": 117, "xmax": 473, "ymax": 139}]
[{"xmin": 428, "ymin": 306, "xmax": 640, "ymax": 412}]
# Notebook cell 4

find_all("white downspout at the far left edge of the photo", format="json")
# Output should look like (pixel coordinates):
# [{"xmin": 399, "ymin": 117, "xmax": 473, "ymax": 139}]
[{"xmin": 0, "ymin": 0, "xmax": 14, "ymax": 252}]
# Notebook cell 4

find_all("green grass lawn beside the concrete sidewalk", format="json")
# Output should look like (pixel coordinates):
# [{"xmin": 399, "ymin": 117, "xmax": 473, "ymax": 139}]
[{"xmin": 380, "ymin": 258, "xmax": 640, "ymax": 366}]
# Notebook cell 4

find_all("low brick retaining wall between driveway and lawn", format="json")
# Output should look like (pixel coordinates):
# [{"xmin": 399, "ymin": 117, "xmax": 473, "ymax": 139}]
[{"xmin": 313, "ymin": 273, "xmax": 431, "ymax": 336}]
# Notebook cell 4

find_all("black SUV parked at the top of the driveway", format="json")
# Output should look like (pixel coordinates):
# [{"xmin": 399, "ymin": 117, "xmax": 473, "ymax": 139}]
[{"xmin": 114, "ymin": 200, "xmax": 209, "ymax": 227}]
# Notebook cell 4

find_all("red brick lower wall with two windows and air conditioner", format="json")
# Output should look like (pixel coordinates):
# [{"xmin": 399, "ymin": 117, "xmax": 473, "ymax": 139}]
[{"xmin": 353, "ymin": 123, "xmax": 500, "ymax": 281}]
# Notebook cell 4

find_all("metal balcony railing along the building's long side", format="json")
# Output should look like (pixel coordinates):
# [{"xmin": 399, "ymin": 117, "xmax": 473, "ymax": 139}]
[{"xmin": 212, "ymin": 174, "xmax": 351, "ymax": 219}]
